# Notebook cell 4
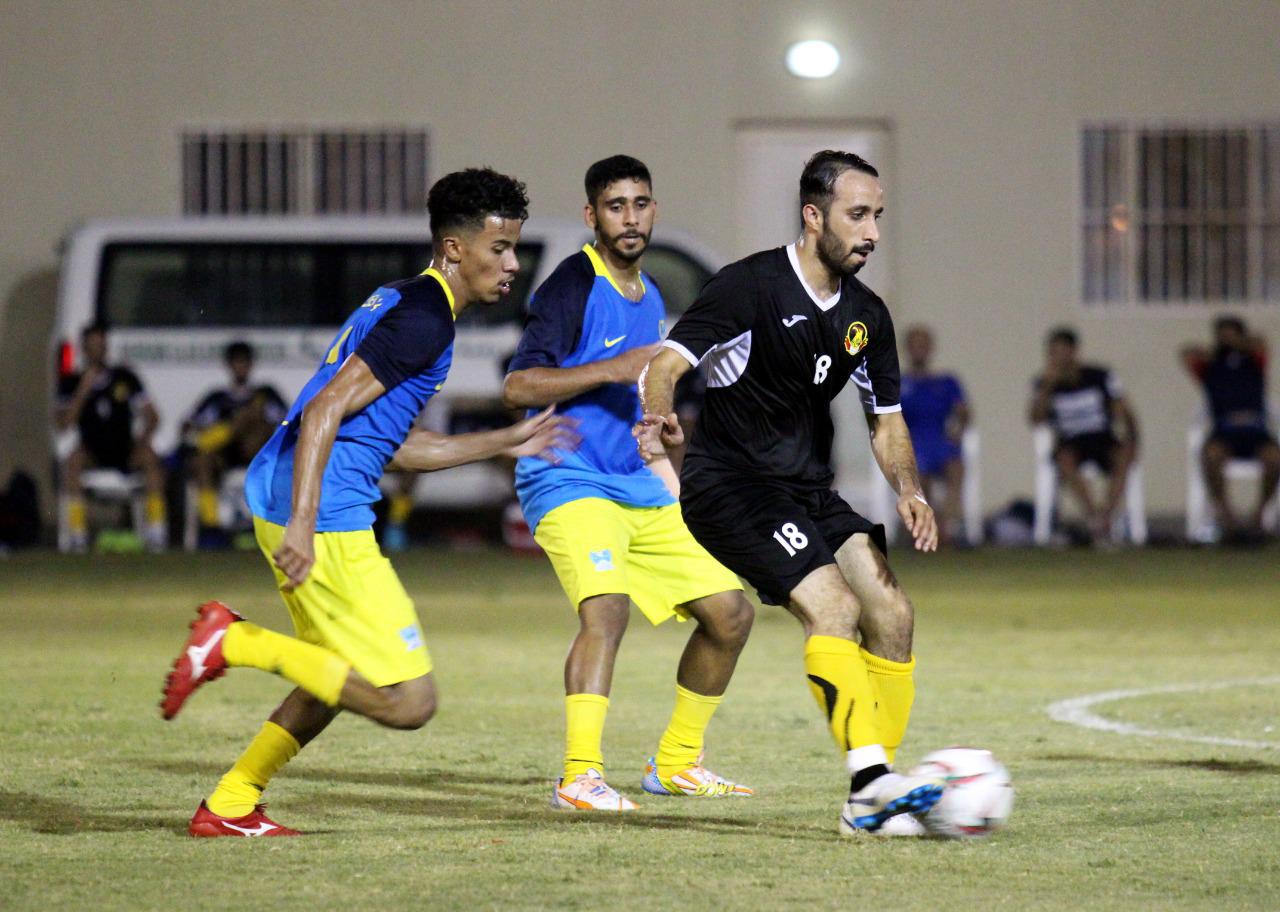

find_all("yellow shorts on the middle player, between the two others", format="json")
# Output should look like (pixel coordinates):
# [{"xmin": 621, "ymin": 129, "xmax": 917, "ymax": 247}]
[{"xmin": 534, "ymin": 497, "xmax": 742, "ymax": 624}]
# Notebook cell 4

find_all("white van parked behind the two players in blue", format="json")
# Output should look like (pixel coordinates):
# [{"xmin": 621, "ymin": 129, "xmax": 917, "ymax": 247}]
[{"xmin": 52, "ymin": 216, "xmax": 722, "ymax": 506}]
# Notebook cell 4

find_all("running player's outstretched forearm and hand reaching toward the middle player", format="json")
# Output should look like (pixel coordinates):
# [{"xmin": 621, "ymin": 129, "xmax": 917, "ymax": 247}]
[{"xmin": 387, "ymin": 407, "xmax": 581, "ymax": 471}]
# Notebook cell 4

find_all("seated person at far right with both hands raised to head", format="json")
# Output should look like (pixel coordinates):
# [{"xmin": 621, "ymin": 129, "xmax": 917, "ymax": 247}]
[{"xmin": 1183, "ymin": 316, "xmax": 1280, "ymax": 535}]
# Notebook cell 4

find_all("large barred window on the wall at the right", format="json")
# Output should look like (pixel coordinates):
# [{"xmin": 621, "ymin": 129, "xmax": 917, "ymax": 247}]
[{"xmin": 1082, "ymin": 126, "xmax": 1280, "ymax": 306}]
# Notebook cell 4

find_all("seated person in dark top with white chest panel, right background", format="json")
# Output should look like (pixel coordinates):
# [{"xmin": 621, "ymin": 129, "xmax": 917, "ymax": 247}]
[{"xmin": 1030, "ymin": 327, "xmax": 1138, "ymax": 542}]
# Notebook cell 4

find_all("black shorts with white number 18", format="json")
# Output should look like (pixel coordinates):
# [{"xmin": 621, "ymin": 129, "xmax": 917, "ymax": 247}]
[{"xmin": 680, "ymin": 476, "xmax": 888, "ymax": 605}]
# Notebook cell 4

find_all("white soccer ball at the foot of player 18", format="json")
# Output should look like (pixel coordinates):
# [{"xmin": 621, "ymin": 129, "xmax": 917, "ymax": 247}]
[{"xmin": 911, "ymin": 747, "xmax": 1014, "ymax": 839}]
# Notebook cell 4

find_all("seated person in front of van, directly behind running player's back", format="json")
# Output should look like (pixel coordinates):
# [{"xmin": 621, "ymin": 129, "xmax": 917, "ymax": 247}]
[{"xmin": 184, "ymin": 342, "xmax": 288, "ymax": 529}]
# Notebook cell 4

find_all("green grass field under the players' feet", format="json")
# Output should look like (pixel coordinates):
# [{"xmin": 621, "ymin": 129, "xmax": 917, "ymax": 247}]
[{"xmin": 0, "ymin": 548, "xmax": 1280, "ymax": 912}]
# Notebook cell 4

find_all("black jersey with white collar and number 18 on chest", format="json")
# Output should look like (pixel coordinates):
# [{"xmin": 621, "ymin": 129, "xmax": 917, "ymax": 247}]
[{"xmin": 664, "ymin": 246, "xmax": 901, "ymax": 488}]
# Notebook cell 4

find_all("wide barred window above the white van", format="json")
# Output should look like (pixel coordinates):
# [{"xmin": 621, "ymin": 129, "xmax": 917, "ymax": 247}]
[{"xmin": 182, "ymin": 129, "xmax": 428, "ymax": 215}]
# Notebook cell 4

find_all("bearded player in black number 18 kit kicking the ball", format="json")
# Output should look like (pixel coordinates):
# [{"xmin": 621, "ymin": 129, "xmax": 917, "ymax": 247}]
[{"xmin": 635, "ymin": 151, "xmax": 942, "ymax": 835}]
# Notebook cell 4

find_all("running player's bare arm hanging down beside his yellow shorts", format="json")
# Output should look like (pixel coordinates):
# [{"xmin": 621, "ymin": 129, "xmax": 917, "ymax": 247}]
[{"xmin": 273, "ymin": 354, "xmax": 387, "ymax": 585}]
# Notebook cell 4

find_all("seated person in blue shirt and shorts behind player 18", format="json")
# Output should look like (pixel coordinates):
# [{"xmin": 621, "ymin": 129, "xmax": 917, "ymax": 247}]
[{"xmin": 901, "ymin": 325, "xmax": 973, "ymax": 543}]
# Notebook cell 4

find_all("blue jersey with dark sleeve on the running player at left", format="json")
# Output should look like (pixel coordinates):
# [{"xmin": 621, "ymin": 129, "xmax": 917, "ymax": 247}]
[{"xmin": 244, "ymin": 269, "xmax": 453, "ymax": 532}]
